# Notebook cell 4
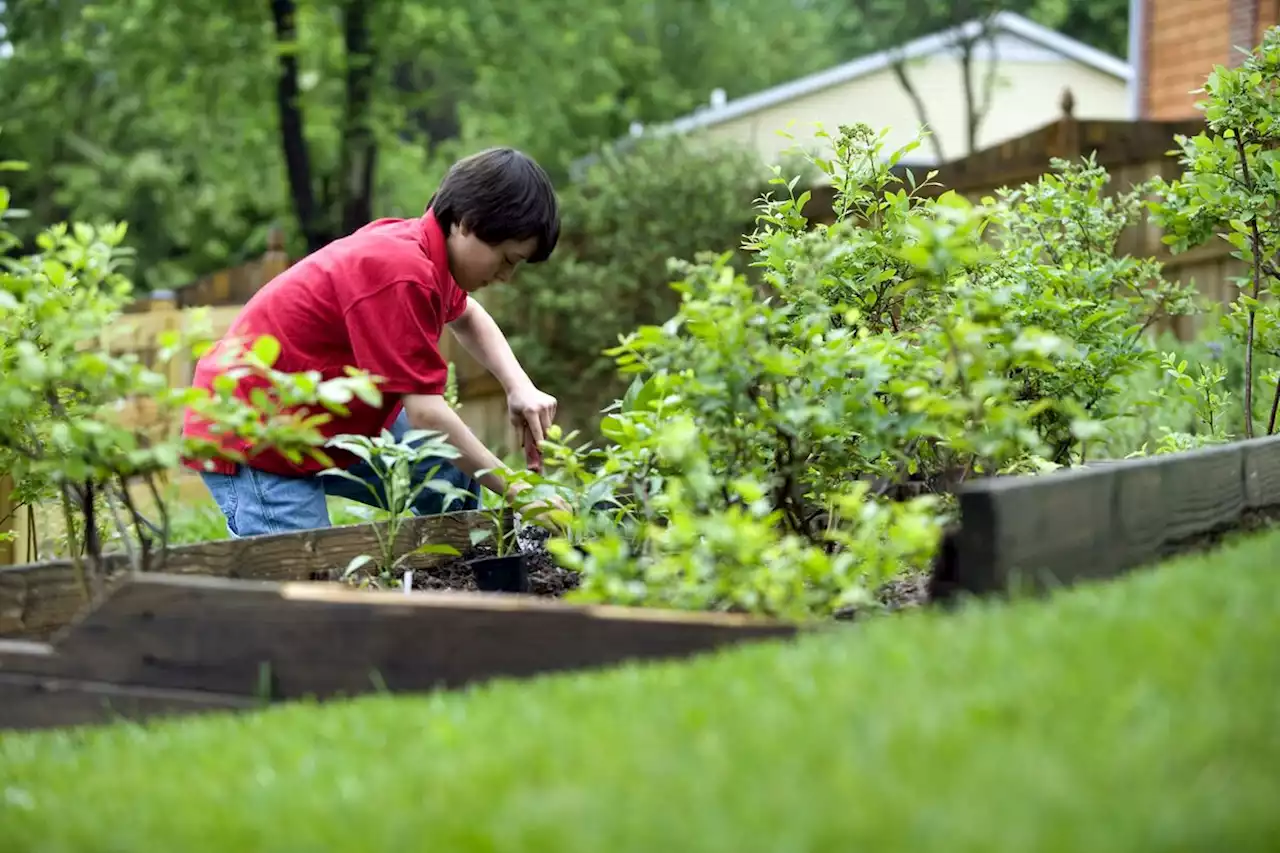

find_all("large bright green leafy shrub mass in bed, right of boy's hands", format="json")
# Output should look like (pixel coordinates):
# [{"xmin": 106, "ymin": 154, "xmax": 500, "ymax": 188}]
[{"xmin": 532, "ymin": 127, "xmax": 1188, "ymax": 616}]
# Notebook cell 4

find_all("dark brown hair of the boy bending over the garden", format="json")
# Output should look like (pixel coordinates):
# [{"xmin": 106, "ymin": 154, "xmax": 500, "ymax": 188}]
[{"xmin": 426, "ymin": 149, "xmax": 559, "ymax": 264}]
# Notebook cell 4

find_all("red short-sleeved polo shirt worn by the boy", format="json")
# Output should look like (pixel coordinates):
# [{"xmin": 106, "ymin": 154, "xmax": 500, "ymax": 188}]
[{"xmin": 183, "ymin": 210, "xmax": 467, "ymax": 475}]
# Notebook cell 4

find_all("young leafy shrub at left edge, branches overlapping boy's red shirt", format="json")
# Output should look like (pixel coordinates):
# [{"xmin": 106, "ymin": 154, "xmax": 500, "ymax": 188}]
[{"xmin": 0, "ymin": 163, "xmax": 379, "ymax": 594}]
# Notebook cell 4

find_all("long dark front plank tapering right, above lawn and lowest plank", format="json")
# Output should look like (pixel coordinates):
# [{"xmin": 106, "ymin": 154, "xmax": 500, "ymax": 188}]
[{"xmin": 17, "ymin": 575, "xmax": 797, "ymax": 699}]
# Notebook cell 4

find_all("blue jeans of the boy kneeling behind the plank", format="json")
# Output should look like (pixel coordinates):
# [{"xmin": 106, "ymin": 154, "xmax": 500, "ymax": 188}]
[{"xmin": 201, "ymin": 411, "xmax": 480, "ymax": 537}]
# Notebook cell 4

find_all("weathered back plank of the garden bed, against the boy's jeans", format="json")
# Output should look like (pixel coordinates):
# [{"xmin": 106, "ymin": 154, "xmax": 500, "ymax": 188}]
[{"xmin": 0, "ymin": 504, "xmax": 490, "ymax": 638}]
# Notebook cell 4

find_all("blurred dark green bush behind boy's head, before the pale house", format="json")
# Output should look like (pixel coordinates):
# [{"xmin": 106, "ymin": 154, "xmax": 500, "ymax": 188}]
[{"xmin": 481, "ymin": 136, "xmax": 812, "ymax": 432}]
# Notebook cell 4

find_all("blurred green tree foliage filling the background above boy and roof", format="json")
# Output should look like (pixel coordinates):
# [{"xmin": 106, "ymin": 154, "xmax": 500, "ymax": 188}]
[{"xmin": 0, "ymin": 0, "xmax": 1125, "ymax": 289}]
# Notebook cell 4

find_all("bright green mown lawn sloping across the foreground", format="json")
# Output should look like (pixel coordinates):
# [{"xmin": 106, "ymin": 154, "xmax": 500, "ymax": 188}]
[{"xmin": 0, "ymin": 533, "xmax": 1280, "ymax": 853}]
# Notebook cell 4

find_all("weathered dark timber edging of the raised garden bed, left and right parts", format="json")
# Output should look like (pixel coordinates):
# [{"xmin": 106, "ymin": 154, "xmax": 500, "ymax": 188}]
[{"xmin": 0, "ymin": 437, "xmax": 1280, "ymax": 727}]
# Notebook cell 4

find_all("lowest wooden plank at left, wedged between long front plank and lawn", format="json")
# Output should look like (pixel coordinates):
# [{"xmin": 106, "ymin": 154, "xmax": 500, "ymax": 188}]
[{"xmin": 0, "ymin": 672, "xmax": 260, "ymax": 730}]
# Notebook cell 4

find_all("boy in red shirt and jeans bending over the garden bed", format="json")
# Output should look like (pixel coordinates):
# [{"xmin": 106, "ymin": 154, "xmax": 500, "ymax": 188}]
[{"xmin": 183, "ymin": 149, "xmax": 559, "ymax": 537}]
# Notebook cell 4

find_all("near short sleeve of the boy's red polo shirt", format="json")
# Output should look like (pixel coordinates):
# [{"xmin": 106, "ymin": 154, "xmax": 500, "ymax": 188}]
[{"xmin": 344, "ymin": 282, "xmax": 452, "ymax": 394}]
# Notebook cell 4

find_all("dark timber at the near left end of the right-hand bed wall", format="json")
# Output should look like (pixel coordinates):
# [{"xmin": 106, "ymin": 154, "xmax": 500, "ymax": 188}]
[{"xmin": 955, "ymin": 465, "xmax": 1119, "ymax": 593}]
